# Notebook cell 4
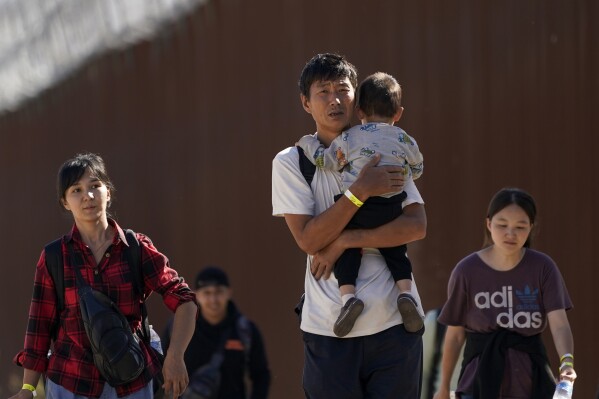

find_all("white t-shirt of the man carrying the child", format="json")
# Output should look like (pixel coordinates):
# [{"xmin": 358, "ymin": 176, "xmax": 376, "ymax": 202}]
[{"xmin": 272, "ymin": 147, "xmax": 424, "ymax": 338}]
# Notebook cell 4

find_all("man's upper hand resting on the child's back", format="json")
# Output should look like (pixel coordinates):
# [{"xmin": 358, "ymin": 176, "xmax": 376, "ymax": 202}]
[{"xmin": 350, "ymin": 154, "xmax": 405, "ymax": 202}]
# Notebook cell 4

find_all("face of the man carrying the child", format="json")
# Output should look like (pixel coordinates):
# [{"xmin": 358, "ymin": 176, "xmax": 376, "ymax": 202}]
[{"xmin": 301, "ymin": 77, "xmax": 355, "ymax": 138}]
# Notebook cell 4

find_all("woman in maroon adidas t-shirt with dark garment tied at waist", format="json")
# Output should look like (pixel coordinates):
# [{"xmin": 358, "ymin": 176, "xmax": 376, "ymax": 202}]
[{"xmin": 435, "ymin": 188, "xmax": 576, "ymax": 399}]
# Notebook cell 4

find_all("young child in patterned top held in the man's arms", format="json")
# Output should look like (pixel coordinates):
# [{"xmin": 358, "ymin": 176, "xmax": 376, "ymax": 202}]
[{"xmin": 298, "ymin": 72, "xmax": 423, "ymax": 337}]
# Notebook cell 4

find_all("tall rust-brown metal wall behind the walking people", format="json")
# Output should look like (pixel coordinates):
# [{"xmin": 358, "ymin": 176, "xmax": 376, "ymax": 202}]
[{"xmin": 0, "ymin": 0, "xmax": 599, "ymax": 399}]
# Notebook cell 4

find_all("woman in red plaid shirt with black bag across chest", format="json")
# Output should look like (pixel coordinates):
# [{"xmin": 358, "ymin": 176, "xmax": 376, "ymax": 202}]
[{"xmin": 11, "ymin": 153, "xmax": 197, "ymax": 399}]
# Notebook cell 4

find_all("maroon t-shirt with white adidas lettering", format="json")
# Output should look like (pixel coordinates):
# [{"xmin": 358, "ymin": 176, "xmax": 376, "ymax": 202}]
[{"xmin": 439, "ymin": 249, "xmax": 572, "ymax": 399}]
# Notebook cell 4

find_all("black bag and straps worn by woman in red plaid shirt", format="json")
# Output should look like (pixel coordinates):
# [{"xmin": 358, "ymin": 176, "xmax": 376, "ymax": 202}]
[{"xmin": 45, "ymin": 230, "xmax": 163, "ymax": 394}]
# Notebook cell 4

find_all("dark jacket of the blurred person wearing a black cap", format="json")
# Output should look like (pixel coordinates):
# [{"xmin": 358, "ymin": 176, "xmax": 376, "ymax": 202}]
[{"xmin": 162, "ymin": 301, "xmax": 270, "ymax": 399}]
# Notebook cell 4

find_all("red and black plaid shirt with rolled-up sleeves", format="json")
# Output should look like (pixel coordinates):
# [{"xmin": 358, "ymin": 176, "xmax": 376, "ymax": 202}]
[{"xmin": 13, "ymin": 220, "xmax": 195, "ymax": 397}]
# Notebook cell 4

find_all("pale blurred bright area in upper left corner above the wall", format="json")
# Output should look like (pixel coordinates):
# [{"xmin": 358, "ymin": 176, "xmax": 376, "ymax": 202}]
[{"xmin": 0, "ymin": 0, "xmax": 208, "ymax": 114}]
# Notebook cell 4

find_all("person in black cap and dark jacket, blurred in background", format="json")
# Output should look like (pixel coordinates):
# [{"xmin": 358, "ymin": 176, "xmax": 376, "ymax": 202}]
[{"xmin": 162, "ymin": 266, "xmax": 270, "ymax": 399}]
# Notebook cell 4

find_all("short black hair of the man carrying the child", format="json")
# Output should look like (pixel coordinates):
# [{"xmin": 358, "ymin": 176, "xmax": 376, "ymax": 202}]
[{"xmin": 298, "ymin": 53, "xmax": 358, "ymax": 97}]
